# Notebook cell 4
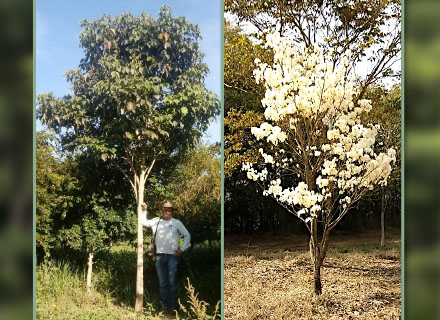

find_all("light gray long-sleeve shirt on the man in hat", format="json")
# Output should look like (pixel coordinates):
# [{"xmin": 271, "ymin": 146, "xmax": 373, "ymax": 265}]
[{"xmin": 142, "ymin": 213, "xmax": 191, "ymax": 254}]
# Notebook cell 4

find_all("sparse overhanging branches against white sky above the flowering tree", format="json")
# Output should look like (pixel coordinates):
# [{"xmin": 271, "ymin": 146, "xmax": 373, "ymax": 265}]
[{"xmin": 225, "ymin": 0, "xmax": 401, "ymax": 99}]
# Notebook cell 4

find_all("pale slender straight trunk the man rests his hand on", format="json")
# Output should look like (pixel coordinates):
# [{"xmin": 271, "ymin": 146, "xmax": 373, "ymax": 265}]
[{"xmin": 134, "ymin": 171, "xmax": 145, "ymax": 312}]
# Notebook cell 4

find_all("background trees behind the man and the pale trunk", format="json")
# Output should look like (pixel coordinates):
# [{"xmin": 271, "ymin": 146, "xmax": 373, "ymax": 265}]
[{"xmin": 36, "ymin": 127, "xmax": 220, "ymax": 262}]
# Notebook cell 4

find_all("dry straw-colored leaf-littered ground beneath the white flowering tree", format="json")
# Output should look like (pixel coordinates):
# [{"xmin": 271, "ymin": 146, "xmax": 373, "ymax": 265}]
[{"xmin": 224, "ymin": 234, "xmax": 401, "ymax": 320}]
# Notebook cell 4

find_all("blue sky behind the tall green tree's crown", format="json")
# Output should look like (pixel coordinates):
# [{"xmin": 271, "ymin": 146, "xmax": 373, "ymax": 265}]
[{"xmin": 36, "ymin": 0, "xmax": 223, "ymax": 143}]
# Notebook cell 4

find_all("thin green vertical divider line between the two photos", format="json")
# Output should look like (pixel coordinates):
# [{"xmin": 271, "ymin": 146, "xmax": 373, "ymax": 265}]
[{"xmin": 220, "ymin": 0, "xmax": 225, "ymax": 320}]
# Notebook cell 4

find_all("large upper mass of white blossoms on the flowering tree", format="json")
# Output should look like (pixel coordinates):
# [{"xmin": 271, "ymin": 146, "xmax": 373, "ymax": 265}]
[{"xmin": 254, "ymin": 33, "xmax": 362, "ymax": 123}]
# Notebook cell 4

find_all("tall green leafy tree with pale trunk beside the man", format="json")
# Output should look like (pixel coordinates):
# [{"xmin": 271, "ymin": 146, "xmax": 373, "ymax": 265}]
[{"xmin": 37, "ymin": 7, "xmax": 220, "ymax": 311}]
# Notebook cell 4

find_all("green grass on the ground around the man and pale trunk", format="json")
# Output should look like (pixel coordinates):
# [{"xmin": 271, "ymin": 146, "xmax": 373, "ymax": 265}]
[{"xmin": 36, "ymin": 242, "xmax": 221, "ymax": 320}]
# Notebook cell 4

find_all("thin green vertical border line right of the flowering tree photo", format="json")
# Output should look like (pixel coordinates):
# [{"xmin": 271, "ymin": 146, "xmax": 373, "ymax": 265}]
[{"xmin": 400, "ymin": 0, "xmax": 405, "ymax": 320}]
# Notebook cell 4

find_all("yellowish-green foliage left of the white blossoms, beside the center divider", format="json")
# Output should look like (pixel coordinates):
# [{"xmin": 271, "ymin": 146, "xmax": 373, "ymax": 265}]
[{"xmin": 224, "ymin": 22, "xmax": 272, "ymax": 179}]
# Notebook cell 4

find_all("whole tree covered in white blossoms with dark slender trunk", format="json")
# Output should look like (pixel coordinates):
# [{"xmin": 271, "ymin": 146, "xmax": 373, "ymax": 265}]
[{"xmin": 242, "ymin": 32, "xmax": 396, "ymax": 295}]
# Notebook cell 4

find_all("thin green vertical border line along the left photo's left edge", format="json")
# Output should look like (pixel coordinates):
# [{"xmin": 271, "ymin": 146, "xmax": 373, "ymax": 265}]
[{"xmin": 32, "ymin": 0, "xmax": 37, "ymax": 319}]
